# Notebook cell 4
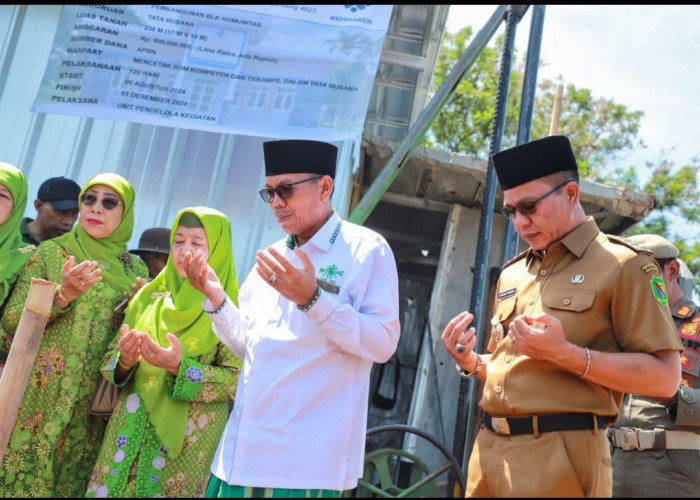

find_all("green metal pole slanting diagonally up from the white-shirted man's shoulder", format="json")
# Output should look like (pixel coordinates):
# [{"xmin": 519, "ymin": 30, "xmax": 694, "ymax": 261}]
[{"xmin": 348, "ymin": 5, "xmax": 508, "ymax": 224}]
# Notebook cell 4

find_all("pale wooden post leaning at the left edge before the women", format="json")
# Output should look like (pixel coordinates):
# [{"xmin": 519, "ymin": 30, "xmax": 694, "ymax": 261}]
[{"xmin": 0, "ymin": 278, "xmax": 57, "ymax": 464}]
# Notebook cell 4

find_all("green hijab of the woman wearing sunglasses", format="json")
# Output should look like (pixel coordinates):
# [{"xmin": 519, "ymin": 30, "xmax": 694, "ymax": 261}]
[{"xmin": 53, "ymin": 173, "xmax": 136, "ymax": 292}]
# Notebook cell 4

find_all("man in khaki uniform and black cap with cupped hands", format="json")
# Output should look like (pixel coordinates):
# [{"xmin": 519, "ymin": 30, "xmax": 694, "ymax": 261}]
[{"xmin": 442, "ymin": 136, "xmax": 683, "ymax": 497}]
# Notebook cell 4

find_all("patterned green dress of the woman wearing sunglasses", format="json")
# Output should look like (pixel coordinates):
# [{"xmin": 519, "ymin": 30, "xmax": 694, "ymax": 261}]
[{"xmin": 0, "ymin": 240, "xmax": 148, "ymax": 497}]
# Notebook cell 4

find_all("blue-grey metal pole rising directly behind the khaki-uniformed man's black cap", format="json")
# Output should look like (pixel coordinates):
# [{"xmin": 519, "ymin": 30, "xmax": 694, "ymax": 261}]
[{"xmin": 502, "ymin": 5, "xmax": 545, "ymax": 264}]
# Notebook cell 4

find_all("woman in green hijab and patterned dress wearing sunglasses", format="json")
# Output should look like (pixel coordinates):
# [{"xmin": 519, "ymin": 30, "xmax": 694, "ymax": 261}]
[{"xmin": 0, "ymin": 173, "xmax": 148, "ymax": 497}]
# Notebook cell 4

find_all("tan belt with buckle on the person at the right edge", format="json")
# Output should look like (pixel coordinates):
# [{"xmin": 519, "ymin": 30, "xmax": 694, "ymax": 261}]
[{"xmin": 607, "ymin": 427, "xmax": 700, "ymax": 451}]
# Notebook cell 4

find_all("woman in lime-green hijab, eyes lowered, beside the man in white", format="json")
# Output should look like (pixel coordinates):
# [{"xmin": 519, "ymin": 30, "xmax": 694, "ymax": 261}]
[{"xmin": 87, "ymin": 207, "xmax": 241, "ymax": 497}]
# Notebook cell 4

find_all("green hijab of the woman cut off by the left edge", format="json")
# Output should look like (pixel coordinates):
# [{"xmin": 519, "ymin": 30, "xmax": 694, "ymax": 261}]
[{"xmin": 0, "ymin": 162, "xmax": 34, "ymax": 310}]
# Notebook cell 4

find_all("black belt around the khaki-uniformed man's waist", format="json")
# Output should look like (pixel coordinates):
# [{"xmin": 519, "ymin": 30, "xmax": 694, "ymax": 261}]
[{"xmin": 482, "ymin": 413, "xmax": 606, "ymax": 436}]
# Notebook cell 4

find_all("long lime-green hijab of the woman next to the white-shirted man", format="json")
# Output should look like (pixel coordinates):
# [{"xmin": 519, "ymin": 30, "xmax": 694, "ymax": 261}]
[{"xmin": 129, "ymin": 207, "xmax": 238, "ymax": 457}]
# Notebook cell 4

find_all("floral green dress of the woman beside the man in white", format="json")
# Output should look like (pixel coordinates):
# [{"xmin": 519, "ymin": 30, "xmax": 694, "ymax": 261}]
[{"xmin": 86, "ymin": 335, "xmax": 241, "ymax": 498}]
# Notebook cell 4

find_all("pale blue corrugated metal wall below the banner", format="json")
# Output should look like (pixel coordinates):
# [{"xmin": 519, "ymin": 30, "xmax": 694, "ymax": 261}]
[{"xmin": 0, "ymin": 5, "xmax": 359, "ymax": 281}]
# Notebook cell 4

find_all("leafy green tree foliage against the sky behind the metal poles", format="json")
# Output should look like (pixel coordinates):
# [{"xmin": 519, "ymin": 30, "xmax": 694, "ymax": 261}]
[{"xmin": 422, "ymin": 26, "xmax": 700, "ymax": 293}]
